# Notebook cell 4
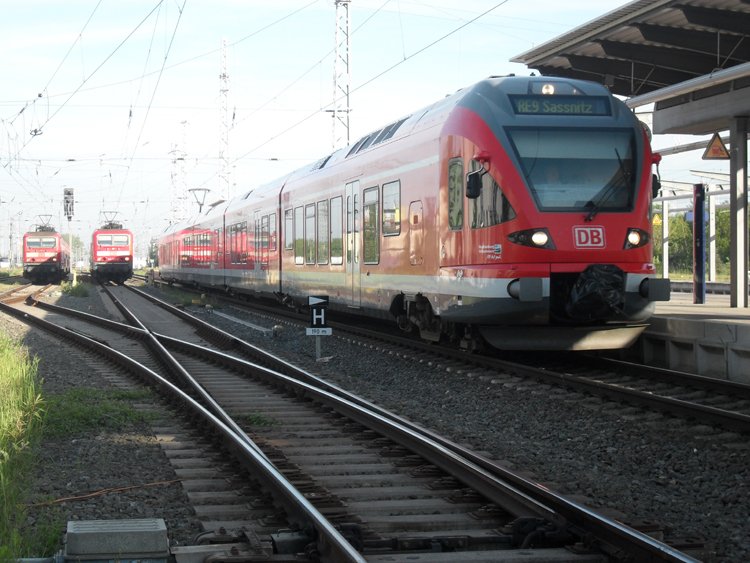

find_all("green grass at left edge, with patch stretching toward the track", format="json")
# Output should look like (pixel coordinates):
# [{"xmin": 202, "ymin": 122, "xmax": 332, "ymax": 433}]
[{"xmin": 0, "ymin": 342, "xmax": 157, "ymax": 561}]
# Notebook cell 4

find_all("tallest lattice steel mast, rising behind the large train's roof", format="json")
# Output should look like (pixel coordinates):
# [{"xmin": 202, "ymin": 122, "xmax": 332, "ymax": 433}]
[{"xmin": 332, "ymin": 0, "xmax": 351, "ymax": 149}]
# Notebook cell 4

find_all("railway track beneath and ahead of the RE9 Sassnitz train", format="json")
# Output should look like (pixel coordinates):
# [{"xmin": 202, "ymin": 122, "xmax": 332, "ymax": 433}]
[{"xmin": 148, "ymin": 278, "xmax": 750, "ymax": 434}]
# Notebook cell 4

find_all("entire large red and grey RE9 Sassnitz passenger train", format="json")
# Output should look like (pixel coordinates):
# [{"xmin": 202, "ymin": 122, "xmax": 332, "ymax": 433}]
[{"xmin": 159, "ymin": 77, "xmax": 669, "ymax": 350}]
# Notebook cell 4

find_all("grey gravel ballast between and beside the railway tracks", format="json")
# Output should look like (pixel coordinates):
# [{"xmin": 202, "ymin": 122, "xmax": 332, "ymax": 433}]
[{"xmin": 0, "ymin": 284, "xmax": 750, "ymax": 563}]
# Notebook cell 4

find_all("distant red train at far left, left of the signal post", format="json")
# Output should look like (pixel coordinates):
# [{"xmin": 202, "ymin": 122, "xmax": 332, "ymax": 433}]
[{"xmin": 23, "ymin": 225, "xmax": 70, "ymax": 283}]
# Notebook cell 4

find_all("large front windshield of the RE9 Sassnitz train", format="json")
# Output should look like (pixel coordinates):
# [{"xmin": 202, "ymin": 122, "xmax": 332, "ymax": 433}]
[{"xmin": 508, "ymin": 128, "xmax": 636, "ymax": 213}]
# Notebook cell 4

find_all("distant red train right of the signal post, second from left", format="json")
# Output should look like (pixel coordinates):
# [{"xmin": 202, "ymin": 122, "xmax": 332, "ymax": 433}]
[{"xmin": 90, "ymin": 221, "xmax": 133, "ymax": 284}]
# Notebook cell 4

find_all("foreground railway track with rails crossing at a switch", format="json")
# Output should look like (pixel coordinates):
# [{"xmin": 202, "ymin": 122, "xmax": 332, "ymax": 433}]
[{"xmin": 3, "ymin": 288, "xmax": 704, "ymax": 561}]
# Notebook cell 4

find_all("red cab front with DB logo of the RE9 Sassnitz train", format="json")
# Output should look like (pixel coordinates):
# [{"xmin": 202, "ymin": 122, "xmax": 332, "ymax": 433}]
[{"xmin": 445, "ymin": 77, "xmax": 669, "ymax": 350}]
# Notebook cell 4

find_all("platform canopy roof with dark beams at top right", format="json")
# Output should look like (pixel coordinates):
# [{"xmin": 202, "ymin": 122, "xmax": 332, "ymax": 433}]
[{"xmin": 511, "ymin": 0, "xmax": 750, "ymax": 97}]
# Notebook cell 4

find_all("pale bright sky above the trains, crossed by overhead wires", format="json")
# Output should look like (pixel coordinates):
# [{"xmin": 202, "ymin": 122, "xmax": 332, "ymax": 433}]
[{"xmin": 0, "ymin": 0, "xmax": 723, "ymax": 255}]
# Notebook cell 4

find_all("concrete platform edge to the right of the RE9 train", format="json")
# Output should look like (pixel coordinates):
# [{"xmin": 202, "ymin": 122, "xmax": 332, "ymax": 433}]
[{"xmin": 628, "ymin": 292, "xmax": 750, "ymax": 384}]
